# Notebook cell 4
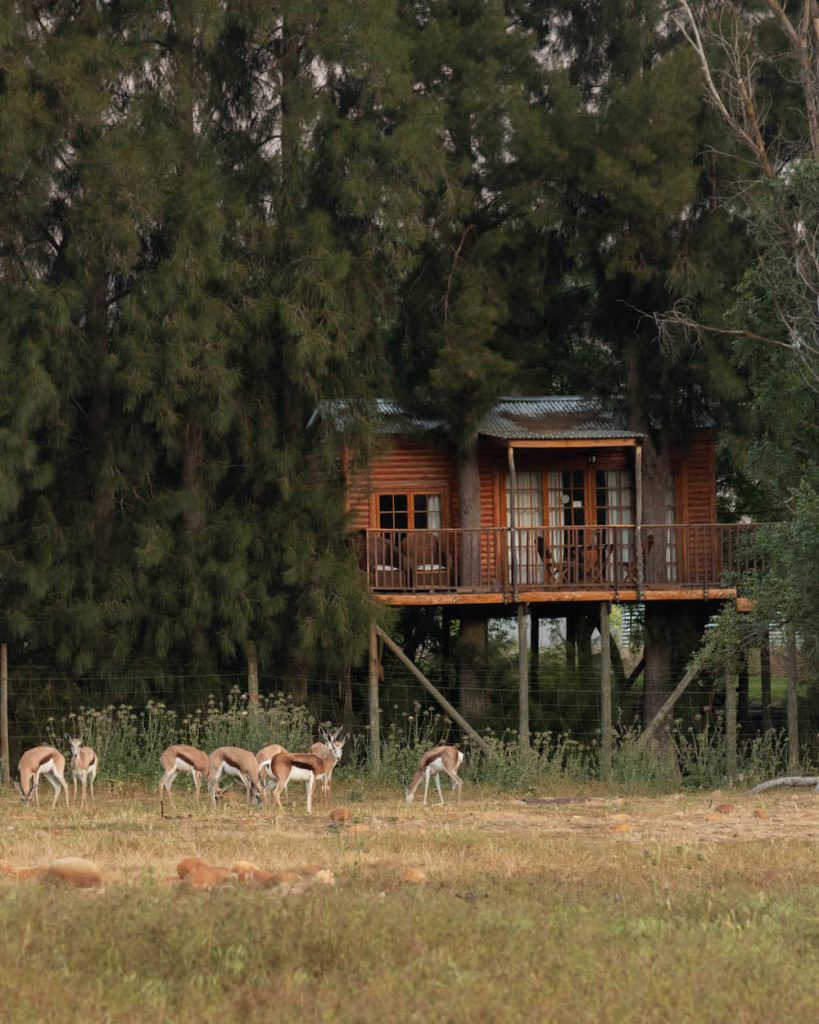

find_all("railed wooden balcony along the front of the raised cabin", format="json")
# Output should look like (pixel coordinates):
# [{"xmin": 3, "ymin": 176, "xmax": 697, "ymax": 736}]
[{"xmin": 360, "ymin": 523, "xmax": 756, "ymax": 604}]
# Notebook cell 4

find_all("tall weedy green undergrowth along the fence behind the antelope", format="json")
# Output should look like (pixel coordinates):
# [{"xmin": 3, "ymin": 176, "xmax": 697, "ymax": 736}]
[{"xmin": 47, "ymin": 687, "xmax": 812, "ymax": 793}]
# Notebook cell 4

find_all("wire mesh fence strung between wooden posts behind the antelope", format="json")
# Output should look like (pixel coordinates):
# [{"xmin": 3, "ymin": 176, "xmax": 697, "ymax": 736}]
[{"xmin": 4, "ymin": 646, "xmax": 815, "ymax": 785}]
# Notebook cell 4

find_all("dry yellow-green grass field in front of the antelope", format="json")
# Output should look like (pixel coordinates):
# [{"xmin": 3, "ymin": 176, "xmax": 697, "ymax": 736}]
[{"xmin": 0, "ymin": 783, "xmax": 819, "ymax": 1024}]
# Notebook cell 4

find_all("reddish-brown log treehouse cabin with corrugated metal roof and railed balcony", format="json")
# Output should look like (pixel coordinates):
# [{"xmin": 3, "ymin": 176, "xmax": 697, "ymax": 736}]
[{"xmin": 316, "ymin": 395, "xmax": 750, "ymax": 605}]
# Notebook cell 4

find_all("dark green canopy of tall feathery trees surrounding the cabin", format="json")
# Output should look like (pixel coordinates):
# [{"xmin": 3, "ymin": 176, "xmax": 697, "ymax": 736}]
[{"xmin": 0, "ymin": 0, "xmax": 819, "ymax": 696}]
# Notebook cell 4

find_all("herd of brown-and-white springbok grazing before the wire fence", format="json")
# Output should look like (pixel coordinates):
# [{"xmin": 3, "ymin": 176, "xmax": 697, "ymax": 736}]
[{"xmin": 14, "ymin": 728, "xmax": 464, "ymax": 814}]
